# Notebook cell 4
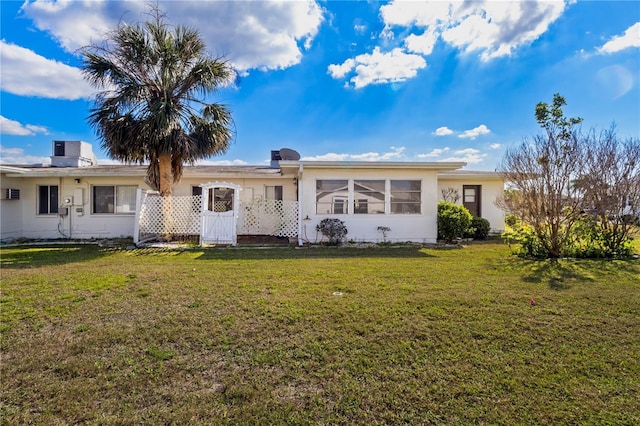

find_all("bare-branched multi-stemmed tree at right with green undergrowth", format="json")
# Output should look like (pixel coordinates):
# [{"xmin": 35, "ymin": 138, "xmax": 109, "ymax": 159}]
[{"xmin": 497, "ymin": 94, "xmax": 640, "ymax": 258}]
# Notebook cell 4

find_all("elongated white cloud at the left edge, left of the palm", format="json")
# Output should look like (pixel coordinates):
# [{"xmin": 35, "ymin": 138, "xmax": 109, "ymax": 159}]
[{"xmin": 0, "ymin": 40, "xmax": 95, "ymax": 100}]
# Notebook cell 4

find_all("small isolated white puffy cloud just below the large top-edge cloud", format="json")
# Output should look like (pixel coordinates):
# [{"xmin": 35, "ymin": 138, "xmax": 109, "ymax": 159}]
[{"xmin": 328, "ymin": 47, "xmax": 427, "ymax": 89}]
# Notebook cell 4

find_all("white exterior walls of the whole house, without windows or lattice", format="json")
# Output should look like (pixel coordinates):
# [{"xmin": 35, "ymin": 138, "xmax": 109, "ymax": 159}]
[{"xmin": 0, "ymin": 163, "xmax": 504, "ymax": 243}]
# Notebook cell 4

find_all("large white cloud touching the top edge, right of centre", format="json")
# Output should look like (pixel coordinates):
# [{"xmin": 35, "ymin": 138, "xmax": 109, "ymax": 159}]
[{"xmin": 380, "ymin": 0, "xmax": 570, "ymax": 61}]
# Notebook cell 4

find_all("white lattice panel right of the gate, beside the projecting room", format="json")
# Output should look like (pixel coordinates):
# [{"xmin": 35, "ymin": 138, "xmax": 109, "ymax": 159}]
[{"xmin": 238, "ymin": 199, "xmax": 298, "ymax": 238}]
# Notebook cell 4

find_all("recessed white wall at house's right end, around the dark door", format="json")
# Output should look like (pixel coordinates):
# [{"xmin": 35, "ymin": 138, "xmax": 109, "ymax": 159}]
[{"xmin": 438, "ymin": 175, "xmax": 505, "ymax": 234}]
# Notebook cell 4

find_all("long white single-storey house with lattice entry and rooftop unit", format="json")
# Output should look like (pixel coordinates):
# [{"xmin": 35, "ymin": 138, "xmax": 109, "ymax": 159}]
[{"xmin": 0, "ymin": 141, "xmax": 504, "ymax": 244}]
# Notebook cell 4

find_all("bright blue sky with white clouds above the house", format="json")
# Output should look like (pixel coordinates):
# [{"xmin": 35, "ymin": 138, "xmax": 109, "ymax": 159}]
[{"xmin": 0, "ymin": 0, "xmax": 640, "ymax": 170}]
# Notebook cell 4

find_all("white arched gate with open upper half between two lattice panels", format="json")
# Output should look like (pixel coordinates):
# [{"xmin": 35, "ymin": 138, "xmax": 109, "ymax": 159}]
[{"xmin": 200, "ymin": 184, "xmax": 238, "ymax": 245}]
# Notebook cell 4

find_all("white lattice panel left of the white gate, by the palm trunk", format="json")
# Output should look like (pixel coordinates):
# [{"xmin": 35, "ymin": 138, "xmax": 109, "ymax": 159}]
[{"xmin": 139, "ymin": 193, "xmax": 202, "ymax": 235}]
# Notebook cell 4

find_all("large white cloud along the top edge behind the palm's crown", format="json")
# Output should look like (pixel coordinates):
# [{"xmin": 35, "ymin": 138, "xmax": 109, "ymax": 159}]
[{"xmin": 22, "ymin": 0, "xmax": 324, "ymax": 71}]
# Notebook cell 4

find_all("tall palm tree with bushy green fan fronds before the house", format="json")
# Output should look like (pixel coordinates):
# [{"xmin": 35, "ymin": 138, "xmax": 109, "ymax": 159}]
[{"xmin": 82, "ymin": 9, "xmax": 235, "ymax": 196}]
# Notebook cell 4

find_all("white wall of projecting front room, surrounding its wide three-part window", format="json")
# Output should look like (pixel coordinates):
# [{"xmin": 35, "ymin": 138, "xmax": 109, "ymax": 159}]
[{"xmin": 300, "ymin": 168, "xmax": 437, "ymax": 243}]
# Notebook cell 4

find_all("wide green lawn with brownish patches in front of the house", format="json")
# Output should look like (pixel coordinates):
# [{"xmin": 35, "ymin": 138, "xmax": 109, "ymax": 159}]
[{"xmin": 0, "ymin": 243, "xmax": 640, "ymax": 425}]
